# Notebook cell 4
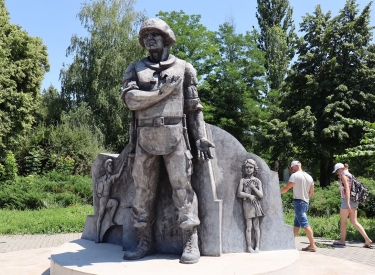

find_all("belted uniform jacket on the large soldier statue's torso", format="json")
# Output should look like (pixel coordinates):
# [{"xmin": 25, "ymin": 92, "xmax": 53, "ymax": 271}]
[{"xmin": 123, "ymin": 55, "xmax": 203, "ymax": 155}]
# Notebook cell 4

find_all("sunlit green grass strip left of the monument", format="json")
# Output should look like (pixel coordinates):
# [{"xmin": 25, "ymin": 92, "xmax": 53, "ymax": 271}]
[{"xmin": 0, "ymin": 205, "xmax": 94, "ymax": 234}]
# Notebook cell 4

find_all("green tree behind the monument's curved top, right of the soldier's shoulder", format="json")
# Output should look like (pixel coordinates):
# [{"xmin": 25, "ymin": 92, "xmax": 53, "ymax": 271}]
[{"xmin": 199, "ymin": 22, "xmax": 266, "ymax": 149}]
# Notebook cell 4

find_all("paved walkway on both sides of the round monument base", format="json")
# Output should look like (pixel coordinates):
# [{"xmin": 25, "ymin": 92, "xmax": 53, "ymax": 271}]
[{"xmin": 0, "ymin": 233, "xmax": 375, "ymax": 275}]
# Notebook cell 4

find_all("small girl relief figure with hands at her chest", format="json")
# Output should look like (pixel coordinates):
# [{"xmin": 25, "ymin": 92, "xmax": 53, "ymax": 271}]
[{"xmin": 237, "ymin": 159, "xmax": 264, "ymax": 253}]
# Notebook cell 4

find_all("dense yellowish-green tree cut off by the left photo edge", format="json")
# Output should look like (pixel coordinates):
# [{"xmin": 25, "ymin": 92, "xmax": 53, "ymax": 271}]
[{"xmin": 0, "ymin": 0, "xmax": 49, "ymax": 157}]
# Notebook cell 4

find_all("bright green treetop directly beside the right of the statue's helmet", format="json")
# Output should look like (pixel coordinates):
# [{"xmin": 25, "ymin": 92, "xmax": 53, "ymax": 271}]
[{"xmin": 156, "ymin": 11, "xmax": 219, "ymax": 77}]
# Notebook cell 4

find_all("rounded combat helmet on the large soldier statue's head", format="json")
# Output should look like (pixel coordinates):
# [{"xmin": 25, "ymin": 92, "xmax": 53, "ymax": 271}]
[{"xmin": 138, "ymin": 18, "xmax": 176, "ymax": 48}]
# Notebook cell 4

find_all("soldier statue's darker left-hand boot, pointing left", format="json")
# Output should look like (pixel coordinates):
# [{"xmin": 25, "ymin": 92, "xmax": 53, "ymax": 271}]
[{"xmin": 124, "ymin": 225, "xmax": 154, "ymax": 260}]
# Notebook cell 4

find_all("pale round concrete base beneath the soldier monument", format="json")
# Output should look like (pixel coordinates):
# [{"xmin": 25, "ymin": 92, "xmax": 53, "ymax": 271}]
[{"xmin": 50, "ymin": 239, "xmax": 299, "ymax": 275}]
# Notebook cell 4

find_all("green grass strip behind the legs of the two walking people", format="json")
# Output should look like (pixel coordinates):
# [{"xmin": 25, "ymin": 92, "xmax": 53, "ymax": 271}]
[{"xmin": 284, "ymin": 211, "xmax": 375, "ymax": 241}]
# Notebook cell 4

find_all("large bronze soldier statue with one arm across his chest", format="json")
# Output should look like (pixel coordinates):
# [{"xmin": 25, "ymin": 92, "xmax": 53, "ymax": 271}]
[{"xmin": 121, "ymin": 18, "xmax": 215, "ymax": 263}]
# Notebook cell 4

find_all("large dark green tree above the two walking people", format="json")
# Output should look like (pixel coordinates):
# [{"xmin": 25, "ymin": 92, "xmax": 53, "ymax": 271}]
[{"xmin": 280, "ymin": 0, "xmax": 375, "ymax": 186}]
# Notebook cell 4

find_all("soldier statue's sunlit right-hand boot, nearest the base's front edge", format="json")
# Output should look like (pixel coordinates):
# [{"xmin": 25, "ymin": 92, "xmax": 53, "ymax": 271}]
[{"xmin": 180, "ymin": 226, "xmax": 200, "ymax": 264}]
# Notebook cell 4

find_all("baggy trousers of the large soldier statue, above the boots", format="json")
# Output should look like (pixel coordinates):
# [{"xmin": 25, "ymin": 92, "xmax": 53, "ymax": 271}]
[{"xmin": 132, "ymin": 139, "xmax": 200, "ymax": 229}]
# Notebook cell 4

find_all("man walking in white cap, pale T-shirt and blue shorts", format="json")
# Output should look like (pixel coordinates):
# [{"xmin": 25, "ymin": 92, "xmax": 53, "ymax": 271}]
[{"xmin": 281, "ymin": 160, "xmax": 316, "ymax": 252}]
